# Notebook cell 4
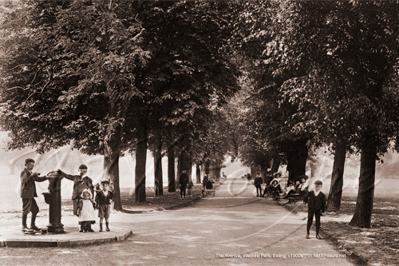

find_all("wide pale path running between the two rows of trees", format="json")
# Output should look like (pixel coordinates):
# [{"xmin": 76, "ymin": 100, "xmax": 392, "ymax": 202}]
[{"xmin": 0, "ymin": 179, "xmax": 352, "ymax": 266}]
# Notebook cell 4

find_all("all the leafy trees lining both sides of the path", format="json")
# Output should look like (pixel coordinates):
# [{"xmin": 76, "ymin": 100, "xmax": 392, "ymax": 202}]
[{"xmin": 0, "ymin": 0, "xmax": 399, "ymax": 227}]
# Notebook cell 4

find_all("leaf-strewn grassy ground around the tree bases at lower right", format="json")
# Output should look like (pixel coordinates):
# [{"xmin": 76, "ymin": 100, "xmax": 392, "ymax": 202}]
[{"xmin": 280, "ymin": 196, "xmax": 399, "ymax": 265}]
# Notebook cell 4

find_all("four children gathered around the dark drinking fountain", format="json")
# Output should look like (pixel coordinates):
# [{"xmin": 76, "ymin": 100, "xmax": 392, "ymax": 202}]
[{"xmin": 21, "ymin": 158, "xmax": 113, "ymax": 232}]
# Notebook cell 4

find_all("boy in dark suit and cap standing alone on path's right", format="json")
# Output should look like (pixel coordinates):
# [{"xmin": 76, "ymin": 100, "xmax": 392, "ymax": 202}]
[{"xmin": 305, "ymin": 180, "xmax": 327, "ymax": 239}]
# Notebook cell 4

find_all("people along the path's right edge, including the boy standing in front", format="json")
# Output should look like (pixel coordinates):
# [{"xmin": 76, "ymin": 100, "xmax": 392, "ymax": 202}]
[{"xmin": 254, "ymin": 173, "xmax": 327, "ymax": 239}]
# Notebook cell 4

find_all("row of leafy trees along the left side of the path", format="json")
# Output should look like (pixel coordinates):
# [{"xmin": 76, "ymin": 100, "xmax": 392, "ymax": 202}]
[{"xmin": 0, "ymin": 0, "xmax": 238, "ymax": 210}]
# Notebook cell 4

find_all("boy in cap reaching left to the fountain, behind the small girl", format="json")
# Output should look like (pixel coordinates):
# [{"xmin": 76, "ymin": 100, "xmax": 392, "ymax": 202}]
[{"xmin": 58, "ymin": 164, "xmax": 94, "ymax": 216}]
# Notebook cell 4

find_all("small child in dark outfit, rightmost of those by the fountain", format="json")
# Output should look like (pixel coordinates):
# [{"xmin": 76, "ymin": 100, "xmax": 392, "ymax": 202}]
[{"xmin": 96, "ymin": 180, "xmax": 114, "ymax": 232}]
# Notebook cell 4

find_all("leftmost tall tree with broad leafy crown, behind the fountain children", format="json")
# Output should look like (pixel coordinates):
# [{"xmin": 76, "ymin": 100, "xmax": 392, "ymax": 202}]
[{"xmin": 1, "ymin": 0, "xmax": 149, "ymax": 210}]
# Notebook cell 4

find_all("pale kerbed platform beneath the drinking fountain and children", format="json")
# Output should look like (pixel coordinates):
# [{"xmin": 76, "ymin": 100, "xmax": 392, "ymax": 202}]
[{"xmin": 0, "ymin": 193, "xmax": 201, "ymax": 248}]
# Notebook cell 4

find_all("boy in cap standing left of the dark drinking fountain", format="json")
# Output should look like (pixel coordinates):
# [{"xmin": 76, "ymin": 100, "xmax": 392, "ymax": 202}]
[{"xmin": 20, "ymin": 158, "xmax": 47, "ymax": 232}]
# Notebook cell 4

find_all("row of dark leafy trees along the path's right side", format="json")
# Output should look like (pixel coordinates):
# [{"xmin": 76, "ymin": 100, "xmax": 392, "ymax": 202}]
[{"xmin": 233, "ymin": 0, "xmax": 399, "ymax": 227}]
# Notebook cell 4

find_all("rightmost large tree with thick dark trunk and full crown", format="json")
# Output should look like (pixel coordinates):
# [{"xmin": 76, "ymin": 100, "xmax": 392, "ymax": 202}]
[{"xmin": 244, "ymin": 1, "xmax": 398, "ymax": 224}]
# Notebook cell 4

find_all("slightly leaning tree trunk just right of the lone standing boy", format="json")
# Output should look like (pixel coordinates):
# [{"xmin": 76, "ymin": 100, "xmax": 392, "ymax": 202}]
[{"xmin": 328, "ymin": 138, "xmax": 346, "ymax": 211}]
